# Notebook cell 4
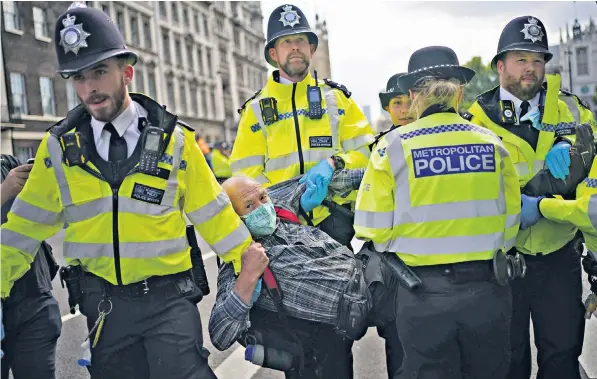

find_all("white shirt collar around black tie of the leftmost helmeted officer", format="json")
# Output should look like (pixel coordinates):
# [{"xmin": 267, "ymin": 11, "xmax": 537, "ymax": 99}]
[{"xmin": 91, "ymin": 100, "xmax": 147, "ymax": 161}]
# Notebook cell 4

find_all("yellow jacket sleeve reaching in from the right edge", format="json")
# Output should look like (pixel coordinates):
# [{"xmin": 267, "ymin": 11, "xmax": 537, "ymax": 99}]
[{"xmin": 539, "ymin": 159, "xmax": 597, "ymax": 251}]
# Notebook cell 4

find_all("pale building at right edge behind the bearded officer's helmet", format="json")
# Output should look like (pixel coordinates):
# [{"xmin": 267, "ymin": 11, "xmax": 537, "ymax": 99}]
[{"xmin": 546, "ymin": 19, "xmax": 597, "ymax": 115}]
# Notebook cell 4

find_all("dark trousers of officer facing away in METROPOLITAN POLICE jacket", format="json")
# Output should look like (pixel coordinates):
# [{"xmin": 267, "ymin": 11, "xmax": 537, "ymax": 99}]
[{"xmin": 395, "ymin": 261, "xmax": 512, "ymax": 379}]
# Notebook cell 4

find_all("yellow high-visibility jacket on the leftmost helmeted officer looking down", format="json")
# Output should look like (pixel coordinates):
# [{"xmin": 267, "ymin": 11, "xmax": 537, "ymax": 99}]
[{"xmin": 1, "ymin": 94, "xmax": 251, "ymax": 298}]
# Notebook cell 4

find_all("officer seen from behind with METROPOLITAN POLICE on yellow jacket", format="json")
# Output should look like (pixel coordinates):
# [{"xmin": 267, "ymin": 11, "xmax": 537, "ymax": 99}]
[{"xmin": 355, "ymin": 46, "xmax": 520, "ymax": 379}]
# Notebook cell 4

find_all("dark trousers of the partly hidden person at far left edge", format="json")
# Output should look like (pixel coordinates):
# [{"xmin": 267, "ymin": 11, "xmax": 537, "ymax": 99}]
[{"xmin": 1, "ymin": 292, "xmax": 62, "ymax": 379}]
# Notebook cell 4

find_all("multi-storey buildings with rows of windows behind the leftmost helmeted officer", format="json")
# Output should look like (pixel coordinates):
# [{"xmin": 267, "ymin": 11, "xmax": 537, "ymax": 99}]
[{"xmin": 1, "ymin": 1, "xmax": 267, "ymax": 159}]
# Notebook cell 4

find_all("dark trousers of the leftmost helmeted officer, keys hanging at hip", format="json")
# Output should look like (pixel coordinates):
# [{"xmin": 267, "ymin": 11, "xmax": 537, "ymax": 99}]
[{"xmin": 79, "ymin": 274, "xmax": 216, "ymax": 379}]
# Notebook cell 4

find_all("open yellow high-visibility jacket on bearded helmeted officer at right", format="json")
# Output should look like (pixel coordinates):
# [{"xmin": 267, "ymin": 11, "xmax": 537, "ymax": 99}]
[{"xmin": 468, "ymin": 75, "xmax": 594, "ymax": 254}]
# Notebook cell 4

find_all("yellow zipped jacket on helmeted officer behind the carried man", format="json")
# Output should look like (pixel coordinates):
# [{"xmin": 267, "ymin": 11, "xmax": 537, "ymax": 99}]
[{"xmin": 230, "ymin": 71, "xmax": 374, "ymax": 225}]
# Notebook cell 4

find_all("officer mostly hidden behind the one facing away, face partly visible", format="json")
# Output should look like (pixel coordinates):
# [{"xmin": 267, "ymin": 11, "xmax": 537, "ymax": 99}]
[{"xmin": 369, "ymin": 72, "xmax": 413, "ymax": 379}]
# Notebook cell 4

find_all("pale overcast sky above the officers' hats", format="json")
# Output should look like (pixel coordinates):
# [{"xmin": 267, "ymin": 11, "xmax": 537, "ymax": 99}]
[{"xmin": 261, "ymin": 0, "xmax": 597, "ymax": 119}]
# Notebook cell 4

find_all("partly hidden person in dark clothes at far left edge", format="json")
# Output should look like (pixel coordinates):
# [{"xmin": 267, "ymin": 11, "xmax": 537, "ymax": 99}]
[{"xmin": 1, "ymin": 154, "xmax": 62, "ymax": 379}]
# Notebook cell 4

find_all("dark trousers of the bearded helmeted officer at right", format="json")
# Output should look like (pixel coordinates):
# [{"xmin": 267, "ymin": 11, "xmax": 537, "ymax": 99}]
[{"xmin": 508, "ymin": 242, "xmax": 585, "ymax": 379}]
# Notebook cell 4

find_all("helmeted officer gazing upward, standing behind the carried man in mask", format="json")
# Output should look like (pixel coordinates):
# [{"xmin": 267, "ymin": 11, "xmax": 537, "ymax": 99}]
[{"xmin": 231, "ymin": 5, "xmax": 373, "ymax": 246}]
